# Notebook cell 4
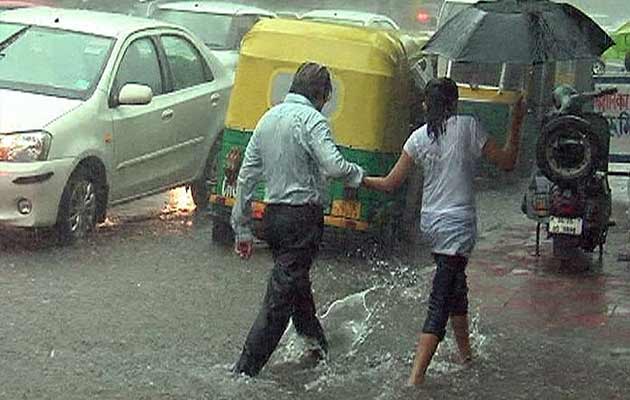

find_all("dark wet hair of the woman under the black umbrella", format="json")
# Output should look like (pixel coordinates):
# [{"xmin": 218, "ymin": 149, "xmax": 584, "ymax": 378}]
[{"xmin": 424, "ymin": 78, "xmax": 459, "ymax": 141}]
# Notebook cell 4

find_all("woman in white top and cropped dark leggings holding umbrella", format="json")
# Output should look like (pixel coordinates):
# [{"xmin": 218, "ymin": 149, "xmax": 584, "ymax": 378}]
[{"xmin": 363, "ymin": 78, "xmax": 526, "ymax": 385}]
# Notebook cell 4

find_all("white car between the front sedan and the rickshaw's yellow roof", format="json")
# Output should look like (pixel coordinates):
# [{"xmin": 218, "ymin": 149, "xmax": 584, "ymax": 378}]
[{"xmin": 150, "ymin": 1, "xmax": 276, "ymax": 74}]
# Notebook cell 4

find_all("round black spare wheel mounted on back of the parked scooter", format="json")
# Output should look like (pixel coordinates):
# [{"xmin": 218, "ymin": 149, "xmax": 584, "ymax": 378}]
[{"xmin": 536, "ymin": 116, "xmax": 603, "ymax": 184}]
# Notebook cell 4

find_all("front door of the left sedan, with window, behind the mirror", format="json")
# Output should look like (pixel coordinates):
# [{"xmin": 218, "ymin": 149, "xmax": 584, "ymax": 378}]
[{"xmin": 110, "ymin": 36, "xmax": 180, "ymax": 202}]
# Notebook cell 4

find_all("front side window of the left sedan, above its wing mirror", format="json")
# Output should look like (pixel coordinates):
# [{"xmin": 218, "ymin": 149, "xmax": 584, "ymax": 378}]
[{"xmin": 114, "ymin": 38, "xmax": 164, "ymax": 96}]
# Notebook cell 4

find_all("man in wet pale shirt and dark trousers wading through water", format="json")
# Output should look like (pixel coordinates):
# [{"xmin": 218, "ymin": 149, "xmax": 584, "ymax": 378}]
[{"xmin": 232, "ymin": 63, "xmax": 364, "ymax": 376}]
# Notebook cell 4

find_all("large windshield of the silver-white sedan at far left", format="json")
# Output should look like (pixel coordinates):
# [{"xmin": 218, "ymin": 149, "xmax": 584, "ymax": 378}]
[{"xmin": 0, "ymin": 23, "xmax": 114, "ymax": 99}]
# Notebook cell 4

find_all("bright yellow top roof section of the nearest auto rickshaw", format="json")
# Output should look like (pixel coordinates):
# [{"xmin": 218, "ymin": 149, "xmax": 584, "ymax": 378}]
[{"xmin": 241, "ymin": 19, "xmax": 407, "ymax": 76}]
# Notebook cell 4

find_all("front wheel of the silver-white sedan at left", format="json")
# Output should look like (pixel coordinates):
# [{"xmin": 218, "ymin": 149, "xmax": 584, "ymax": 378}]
[{"xmin": 55, "ymin": 169, "xmax": 99, "ymax": 244}]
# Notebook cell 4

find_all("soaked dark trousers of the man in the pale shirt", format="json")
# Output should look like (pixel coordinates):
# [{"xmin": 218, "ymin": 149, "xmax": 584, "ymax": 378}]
[{"xmin": 235, "ymin": 204, "xmax": 327, "ymax": 376}]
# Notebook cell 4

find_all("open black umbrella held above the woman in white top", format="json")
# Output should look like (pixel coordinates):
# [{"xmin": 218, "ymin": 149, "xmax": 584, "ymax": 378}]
[{"xmin": 424, "ymin": 0, "xmax": 614, "ymax": 64}]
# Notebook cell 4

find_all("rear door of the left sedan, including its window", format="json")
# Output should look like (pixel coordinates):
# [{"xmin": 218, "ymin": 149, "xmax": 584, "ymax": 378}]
[{"xmin": 159, "ymin": 33, "xmax": 227, "ymax": 181}]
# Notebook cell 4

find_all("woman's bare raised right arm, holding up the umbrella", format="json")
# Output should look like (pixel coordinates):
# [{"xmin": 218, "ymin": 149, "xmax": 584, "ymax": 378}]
[{"xmin": 483, "ymin": 98, "xmax": 527, "ymax": 171}]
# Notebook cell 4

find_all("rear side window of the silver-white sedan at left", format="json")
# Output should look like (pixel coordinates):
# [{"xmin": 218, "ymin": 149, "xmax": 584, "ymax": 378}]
[{"xmin": 160, "ymin": 35, "xmax": 214, "ymax": 90}]
